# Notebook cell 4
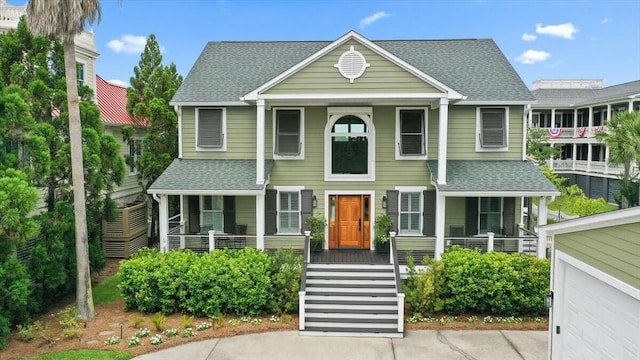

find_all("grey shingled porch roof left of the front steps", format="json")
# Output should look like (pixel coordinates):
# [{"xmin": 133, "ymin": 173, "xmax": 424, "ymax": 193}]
[{"xmin": 148, "ymin": 159, "xmax": 273, "ymax": 195}]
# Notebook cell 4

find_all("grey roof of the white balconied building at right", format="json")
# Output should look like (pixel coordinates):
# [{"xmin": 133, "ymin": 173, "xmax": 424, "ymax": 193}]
[{"xmin": 532, "ymin": 80, "xmax": 640, "ymax": 108}]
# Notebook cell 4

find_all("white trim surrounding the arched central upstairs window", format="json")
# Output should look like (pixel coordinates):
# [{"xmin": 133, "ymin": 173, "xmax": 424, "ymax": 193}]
[{"xmin": 324, "ymin": 107, "xmax": 376, "ymax": 181}]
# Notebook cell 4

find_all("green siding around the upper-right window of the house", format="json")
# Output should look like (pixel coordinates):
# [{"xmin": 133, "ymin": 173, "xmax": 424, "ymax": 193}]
[{"xmin": 444, "ymin": 106, "xmax": 523, "ymax": 160}]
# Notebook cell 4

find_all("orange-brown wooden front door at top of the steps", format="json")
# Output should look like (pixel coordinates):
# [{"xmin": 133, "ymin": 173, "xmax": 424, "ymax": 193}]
[{"xmin": 329, "ymin": 195, "xmax": 370, "ymax": 249}]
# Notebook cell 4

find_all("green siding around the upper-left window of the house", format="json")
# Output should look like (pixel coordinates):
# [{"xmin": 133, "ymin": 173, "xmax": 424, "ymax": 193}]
[{"xmin": 182, "ymin": 106, "xmax": 256, "ymax": 159}]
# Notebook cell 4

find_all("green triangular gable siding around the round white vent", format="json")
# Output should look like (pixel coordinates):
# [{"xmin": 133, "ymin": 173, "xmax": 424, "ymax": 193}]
[{"xmin": 264, "ymin": 40, "xmax": 441, "ymax": 94}]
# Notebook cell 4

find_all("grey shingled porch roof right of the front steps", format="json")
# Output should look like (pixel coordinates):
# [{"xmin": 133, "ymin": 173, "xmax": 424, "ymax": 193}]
[{"xmin": 427, "ymin": 160, "xmax": 560, "ymax": 196}]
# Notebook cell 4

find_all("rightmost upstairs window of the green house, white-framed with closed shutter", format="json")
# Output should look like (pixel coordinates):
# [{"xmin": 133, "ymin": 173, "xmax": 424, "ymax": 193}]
[{"xmin": 476, "ymin": 108, "xmax": 509, "ymax": 151}]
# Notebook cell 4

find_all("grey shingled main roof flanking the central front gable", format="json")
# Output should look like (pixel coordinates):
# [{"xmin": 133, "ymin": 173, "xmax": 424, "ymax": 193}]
[{"xmin": 172, "ymin": 39, "xmax": 534, "ymax": 103}]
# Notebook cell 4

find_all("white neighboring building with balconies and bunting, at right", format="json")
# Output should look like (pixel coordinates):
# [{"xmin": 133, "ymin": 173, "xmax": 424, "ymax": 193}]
[{"xmin": 528, "ymin": 80, "xmax": 640, "ymax": 203}]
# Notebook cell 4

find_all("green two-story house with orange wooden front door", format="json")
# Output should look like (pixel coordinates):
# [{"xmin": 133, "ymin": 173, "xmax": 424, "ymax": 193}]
[{"xmin": 149, "ymin": 32, "xmax": 559, "ymax": 258}]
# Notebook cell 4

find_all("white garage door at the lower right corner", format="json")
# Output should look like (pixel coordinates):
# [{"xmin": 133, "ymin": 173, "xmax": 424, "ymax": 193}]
[{"xmin": 551, "ymin": 255, "xmax": 640, "ymax": 360}]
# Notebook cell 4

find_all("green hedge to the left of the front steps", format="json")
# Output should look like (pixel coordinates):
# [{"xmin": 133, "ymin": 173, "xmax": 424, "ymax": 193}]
[{"xmin": 119, "ymin": 248, "xmax": 301, "ymax": 316}]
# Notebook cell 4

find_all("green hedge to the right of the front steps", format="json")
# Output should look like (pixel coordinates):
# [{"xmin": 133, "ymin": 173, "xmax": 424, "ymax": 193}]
[{"xmin": 405, "ymin": 248, "xmax": 550, "ymax": 316}]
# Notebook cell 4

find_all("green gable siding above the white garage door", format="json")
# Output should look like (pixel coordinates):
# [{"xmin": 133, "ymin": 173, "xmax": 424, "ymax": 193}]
[{"xmin": 554, "ymin": 222, "xmax": 640, "ymax": 289}]
